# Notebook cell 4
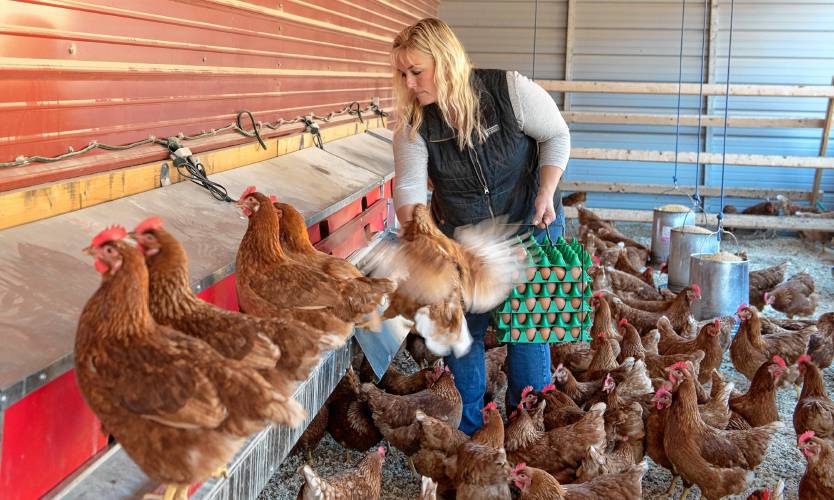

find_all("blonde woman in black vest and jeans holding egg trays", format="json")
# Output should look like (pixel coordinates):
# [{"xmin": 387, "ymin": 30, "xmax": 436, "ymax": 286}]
[{"xmin": 392, "ymin": 18, "xmax": 570, "ymax": 434}]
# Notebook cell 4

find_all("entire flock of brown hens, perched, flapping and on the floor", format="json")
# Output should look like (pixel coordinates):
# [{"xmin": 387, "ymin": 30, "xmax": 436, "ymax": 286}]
[{"xmin": 75, "ymin": 187, "xmax": 834, "ymax": 500}]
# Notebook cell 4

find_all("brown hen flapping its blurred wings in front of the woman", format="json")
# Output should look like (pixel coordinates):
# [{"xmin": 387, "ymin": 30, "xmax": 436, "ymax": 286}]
[{"xmin": 362, "ymin": 204, "xmax": 525, "ymax": 356}]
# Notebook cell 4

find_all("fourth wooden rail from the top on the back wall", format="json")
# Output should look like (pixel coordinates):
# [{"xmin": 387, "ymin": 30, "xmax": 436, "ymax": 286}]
[{"xmin": 559, "ymin": 180, "xmax": 811, "ymax": 201}]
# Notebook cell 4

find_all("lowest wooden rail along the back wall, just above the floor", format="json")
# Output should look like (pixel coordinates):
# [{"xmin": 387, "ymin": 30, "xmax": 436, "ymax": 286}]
[{"xmin": 565, "ymin": 207, "xmax": 834, "ymax": 232}]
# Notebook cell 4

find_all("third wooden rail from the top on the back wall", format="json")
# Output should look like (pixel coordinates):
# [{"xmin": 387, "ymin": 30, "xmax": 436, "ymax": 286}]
[{"xmin": 570, "ymin": 148, "xmax": 834, "ymax": 169}]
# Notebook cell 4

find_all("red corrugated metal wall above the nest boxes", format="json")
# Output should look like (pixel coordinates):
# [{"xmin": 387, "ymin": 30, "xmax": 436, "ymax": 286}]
[{"xmin": 0, "ymin": 0, "xmax": 438, "ymax": 191}]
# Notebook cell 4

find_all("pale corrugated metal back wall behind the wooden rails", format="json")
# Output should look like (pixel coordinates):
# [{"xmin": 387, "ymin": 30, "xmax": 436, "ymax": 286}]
[{"xmin": 440, "ymin": 0, "xmax": 834, "ymax": 211}]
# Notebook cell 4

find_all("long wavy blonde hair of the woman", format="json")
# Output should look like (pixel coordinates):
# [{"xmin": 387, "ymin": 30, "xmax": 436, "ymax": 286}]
[{"xmin": 391, "ymin": 17, "xmax": 484, "ymax": 150}]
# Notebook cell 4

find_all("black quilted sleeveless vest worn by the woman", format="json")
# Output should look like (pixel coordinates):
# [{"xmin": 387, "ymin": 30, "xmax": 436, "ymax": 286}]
[{"xmin": 419, "ymin": 69, "xmax": 562, "ymax": 236}]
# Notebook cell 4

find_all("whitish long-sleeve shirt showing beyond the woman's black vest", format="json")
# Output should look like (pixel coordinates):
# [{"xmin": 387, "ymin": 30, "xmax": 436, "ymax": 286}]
[{"xmin": 394, "ymin": 71, "xmax": 570, "ymax": 208}]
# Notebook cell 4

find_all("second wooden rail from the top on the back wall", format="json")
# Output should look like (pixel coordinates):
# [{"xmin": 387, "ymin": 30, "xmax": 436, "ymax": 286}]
[{"xmin": 562, "ymin": 111, "xmax": 825, "ymax": 128}]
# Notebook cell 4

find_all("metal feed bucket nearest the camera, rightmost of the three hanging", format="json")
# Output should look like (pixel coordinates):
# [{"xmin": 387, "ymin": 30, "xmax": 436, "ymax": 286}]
[{"xmin": 689, "ymin": 252, "xmax": 750, "ymax": 321}]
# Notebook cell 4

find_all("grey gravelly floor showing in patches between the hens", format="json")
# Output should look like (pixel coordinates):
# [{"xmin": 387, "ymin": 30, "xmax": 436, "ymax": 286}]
[{"xmin": 260, "ymin": 224, "xmax": 834, "ymax": 500}]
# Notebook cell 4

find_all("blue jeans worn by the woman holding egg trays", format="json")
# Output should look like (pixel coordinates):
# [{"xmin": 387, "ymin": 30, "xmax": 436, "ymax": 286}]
[{"xmin": 445, "ymin": 210, "xmax": 565, "ymax": 435}]
